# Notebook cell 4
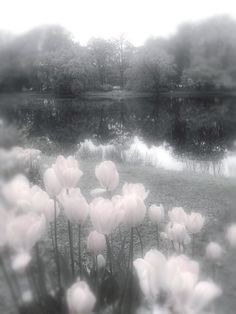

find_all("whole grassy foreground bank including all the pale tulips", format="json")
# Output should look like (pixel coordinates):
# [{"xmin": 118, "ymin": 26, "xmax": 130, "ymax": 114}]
[{"xmin": 1, "ymin": 156, "xmax": 236, "ymax": 314}]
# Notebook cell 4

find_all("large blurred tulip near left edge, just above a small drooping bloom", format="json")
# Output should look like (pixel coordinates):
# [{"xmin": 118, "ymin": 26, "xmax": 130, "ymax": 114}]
[{"xmin": 7, "ymin": 213, "xmax": 46, "ymax": 252}]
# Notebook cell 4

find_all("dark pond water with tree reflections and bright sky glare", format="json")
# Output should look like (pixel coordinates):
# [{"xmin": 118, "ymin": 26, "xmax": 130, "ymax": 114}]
[{"xmin": 0, "ymin": 93, "xmax": 236, "ymax": 175}]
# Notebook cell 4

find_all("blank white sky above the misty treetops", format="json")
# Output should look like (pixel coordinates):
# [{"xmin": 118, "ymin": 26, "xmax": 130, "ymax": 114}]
[{"xmin": 0, "ymin": 0, "xmax": 236, "ymax": 46}]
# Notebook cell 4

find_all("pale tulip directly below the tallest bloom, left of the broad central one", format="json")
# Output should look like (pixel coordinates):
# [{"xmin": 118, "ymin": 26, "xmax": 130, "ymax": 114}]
[{"xmin": 59, "ymin": 188, "xmax": 89, "ymax": 224}]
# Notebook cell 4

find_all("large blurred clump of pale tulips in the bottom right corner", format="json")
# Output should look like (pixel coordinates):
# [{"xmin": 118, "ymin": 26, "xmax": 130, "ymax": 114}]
[{"xmin": 134, "ymin": 250, "xmax": 221, "ymax": 314}]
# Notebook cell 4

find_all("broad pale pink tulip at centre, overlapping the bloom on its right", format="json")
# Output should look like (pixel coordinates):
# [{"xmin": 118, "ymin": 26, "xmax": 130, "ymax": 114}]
[{"xmin": 90, "ymin": 197, "xmax": 123, "ymax": 234}]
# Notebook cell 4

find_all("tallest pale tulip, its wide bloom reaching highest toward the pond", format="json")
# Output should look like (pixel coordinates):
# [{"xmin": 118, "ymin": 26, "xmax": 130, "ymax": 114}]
[{"xmin": 52, "ymin": 156, "xmax": 83, "ymax": 188}]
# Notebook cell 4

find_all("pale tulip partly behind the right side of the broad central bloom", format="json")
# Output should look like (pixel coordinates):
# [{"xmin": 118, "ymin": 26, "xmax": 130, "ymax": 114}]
[{"xmin": 121, "ymin": 194, "xmax": 146, "ymax": 227}]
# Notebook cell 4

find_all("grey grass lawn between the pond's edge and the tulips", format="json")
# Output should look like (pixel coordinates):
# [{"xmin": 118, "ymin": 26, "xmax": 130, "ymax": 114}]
[{"xmin": 0, "ymin": 157, "xmax": 236, "ymax": 314}]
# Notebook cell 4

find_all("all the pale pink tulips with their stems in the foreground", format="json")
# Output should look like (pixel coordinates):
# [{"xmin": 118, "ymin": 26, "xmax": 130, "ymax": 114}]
[{"xmin": 0, "ymin": 156, "xmax": 236, "ymax": 314}]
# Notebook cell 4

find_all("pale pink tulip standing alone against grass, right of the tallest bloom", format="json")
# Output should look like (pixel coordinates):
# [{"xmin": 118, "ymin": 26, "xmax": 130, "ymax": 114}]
[{"xmin": 95, "ymin": 160, "xmax": 119, "ymax": 191}]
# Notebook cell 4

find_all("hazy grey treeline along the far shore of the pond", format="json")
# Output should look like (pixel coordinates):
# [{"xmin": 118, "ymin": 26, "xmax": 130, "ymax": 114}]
[{"xmin": 0, "ymin": 16, "xmax": 236, "ymax": 95}]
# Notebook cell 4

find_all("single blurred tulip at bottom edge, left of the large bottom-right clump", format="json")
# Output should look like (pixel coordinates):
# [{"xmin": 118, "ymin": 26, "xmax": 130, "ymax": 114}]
[{"xmin": 66, "ymin": 281, "xmax": 96, "ymax": 314}]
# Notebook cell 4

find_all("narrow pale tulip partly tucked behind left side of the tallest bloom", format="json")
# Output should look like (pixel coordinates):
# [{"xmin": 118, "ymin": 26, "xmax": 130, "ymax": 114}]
[{"xmin": 43, "ymin": 168, "xmax": 62, "ymax": 197}]
